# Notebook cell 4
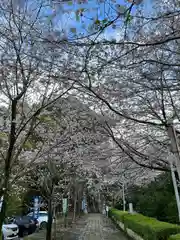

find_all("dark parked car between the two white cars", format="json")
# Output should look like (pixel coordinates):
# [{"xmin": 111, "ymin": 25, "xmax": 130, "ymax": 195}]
[{"xmin": 13, "ymin": 216, "xmax": 38, "ymax": 238}]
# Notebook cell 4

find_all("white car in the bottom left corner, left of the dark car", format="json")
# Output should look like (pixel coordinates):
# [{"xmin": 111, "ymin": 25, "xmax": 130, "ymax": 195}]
[{"xmin": 2, "ymin": 223, "xmax": 19, "ymax": 240}]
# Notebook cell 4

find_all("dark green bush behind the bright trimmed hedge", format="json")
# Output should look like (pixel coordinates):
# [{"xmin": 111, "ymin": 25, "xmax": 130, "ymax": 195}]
[{"xmin": 126, "ymin": 172, "xmax": 179, "ymax": 224}]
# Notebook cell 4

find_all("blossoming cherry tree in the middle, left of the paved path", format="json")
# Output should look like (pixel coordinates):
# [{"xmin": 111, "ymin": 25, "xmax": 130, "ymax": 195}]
[{"xmin": 12, "ymin": 96, "xmax": 113, "ymax": 239}]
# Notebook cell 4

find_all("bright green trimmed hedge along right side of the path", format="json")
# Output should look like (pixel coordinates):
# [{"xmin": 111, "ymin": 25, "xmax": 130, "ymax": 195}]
[{"xmin": 109, "ymin": 209, "xmax": 180, "ymax": 240}]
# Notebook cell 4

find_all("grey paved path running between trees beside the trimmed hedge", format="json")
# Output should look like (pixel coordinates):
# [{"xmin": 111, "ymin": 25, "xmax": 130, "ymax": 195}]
[{"xmin": 68, "ymin": 214, "xmax": 128, "ymax": 240}]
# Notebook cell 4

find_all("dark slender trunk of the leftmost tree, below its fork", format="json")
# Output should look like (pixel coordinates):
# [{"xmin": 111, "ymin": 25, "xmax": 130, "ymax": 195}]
[{"xmin": 0, "ymin": 100, "xmax": 17, "ymax": 235}]
